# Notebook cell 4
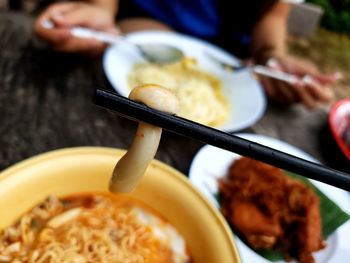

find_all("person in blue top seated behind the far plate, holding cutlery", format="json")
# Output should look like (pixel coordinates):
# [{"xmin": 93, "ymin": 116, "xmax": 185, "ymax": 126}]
[{"xmin": 34, "ymin": 0, "xmax": 339, "ymax": 109}]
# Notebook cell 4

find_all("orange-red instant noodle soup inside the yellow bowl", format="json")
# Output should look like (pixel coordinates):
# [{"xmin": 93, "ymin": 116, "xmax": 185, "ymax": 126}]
[{"xmin": 0, "ymin": 193, "xmax": 190, "ymax": 262}]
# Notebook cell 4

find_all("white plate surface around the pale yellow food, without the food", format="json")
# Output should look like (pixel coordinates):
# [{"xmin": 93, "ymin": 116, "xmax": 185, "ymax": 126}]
[{"xmin": 103, "ymin": 31, "xmax": 266, "ymax": 131}]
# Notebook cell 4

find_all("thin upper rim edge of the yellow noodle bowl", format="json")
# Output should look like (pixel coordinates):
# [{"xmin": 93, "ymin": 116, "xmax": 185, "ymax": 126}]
[{"xmin": 0, "ymin": 146, "xmax": 241, "ymax": 263}]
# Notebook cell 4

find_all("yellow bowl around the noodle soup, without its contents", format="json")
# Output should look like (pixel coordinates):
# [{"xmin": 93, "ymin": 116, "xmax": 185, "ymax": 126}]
[{"xmin": 0, "ymin": 147, "xmax": 240, "ymax": 263}]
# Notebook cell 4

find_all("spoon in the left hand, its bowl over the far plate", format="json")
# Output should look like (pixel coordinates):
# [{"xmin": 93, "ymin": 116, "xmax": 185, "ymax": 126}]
[{"xmin": 42, "ymin": 20, "xmax": 185, "ymax": 64}]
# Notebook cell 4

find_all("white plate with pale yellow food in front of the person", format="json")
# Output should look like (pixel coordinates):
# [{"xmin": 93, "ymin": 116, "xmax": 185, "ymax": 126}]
[{"xmin": 103, "ymin": 31, "xmax": 266, "ymax": 132}]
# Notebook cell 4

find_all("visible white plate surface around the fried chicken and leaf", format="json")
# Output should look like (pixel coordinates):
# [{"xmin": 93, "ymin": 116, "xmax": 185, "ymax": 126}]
[{"xmin": 189, "ymin": 134, "xmax": 350, "ymax": 263}]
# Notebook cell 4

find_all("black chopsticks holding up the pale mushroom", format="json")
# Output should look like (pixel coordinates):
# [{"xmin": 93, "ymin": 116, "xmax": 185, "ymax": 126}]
[{"xmin": 93, "ymin": 89, "xmax": 350, "ymax": 191}]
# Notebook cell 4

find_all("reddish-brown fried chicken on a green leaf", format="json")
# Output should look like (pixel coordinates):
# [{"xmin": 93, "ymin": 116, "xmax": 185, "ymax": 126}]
[{"xmin": 219, "ymin": 157, "xmax": 324, "ymax": 263}]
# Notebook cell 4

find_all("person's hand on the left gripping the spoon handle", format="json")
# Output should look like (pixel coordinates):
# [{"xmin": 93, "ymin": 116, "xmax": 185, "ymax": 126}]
[{"xmin": 34, "ymin": 2, "xmax": 118, "ymax": 55}]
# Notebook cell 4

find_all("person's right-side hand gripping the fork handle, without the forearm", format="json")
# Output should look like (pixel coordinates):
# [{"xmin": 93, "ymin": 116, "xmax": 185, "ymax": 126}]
[{"xmin": 259, "ymin": 54, "xmax": 341, "ymax": 110}]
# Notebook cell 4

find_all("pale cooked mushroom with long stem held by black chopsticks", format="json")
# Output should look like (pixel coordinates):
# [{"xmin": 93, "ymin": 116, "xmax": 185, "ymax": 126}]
[{"xmin": 109, "ymin": 84, "xmax": 179, "ymax": 193}]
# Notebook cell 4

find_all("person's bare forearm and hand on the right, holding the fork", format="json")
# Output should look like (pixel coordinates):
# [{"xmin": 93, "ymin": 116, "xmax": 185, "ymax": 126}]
[{"xmin": 251, "ymin": 2, "xmax": 338, "ymax": 109}]
